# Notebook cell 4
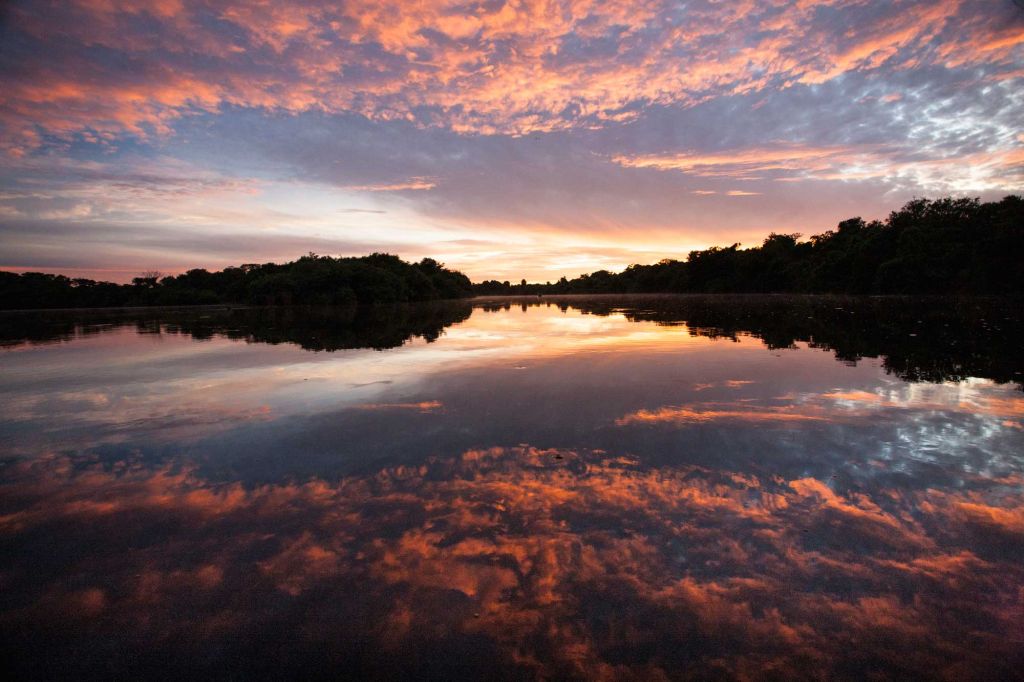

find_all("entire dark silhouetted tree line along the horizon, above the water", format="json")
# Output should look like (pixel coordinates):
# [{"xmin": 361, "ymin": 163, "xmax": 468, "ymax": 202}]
[{"xmin": 0, "ymin": 196, "xmax": 1024, "ymax": 309}]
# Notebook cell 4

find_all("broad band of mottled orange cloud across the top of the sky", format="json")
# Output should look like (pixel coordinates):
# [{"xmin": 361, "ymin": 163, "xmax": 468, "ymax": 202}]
[{"xmin": 5, "ymin": 0, "xmax": 1021, "ymax": 148}]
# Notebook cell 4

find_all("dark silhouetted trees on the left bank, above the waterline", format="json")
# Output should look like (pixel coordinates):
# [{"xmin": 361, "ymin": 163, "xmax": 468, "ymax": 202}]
[{"xmin": 0, "ymin": 253, "xmax": 472, "ymax": 309}]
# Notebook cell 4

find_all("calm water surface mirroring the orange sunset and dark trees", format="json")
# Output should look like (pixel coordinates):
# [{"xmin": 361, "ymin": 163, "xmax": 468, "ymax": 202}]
[{"xmin": 0, "ymin": 297, "xmax": 1024, "ymax": 679}]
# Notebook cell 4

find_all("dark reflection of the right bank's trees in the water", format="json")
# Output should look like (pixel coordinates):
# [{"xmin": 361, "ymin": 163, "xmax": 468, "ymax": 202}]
[{"xmin": 552, "ymin": 294, "xmax": 1024, "ymax": 390}]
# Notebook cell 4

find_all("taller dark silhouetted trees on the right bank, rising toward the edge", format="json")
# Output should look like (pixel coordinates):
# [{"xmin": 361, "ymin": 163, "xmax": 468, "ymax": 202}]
[{"xmin": 473, "ymin": 196, "xmax": 1024, "ymax": 295}]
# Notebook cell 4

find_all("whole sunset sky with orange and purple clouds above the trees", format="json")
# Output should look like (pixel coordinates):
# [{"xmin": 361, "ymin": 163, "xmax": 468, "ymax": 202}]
[{"xmin": 0, "ymin": 0, "xmax": 1024, "ymax": 282}]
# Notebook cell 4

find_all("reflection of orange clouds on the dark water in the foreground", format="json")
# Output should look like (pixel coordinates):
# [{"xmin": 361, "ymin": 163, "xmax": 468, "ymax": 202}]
[{"xmin": 0, "ymin": 445, "xmax": 1024, "ymax": 677}]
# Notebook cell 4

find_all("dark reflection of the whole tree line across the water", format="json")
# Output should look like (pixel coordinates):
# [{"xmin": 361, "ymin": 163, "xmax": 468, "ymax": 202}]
[{"xmin": 6, "ymin": 294, "xmax": 1024, "ymax": 390}]
